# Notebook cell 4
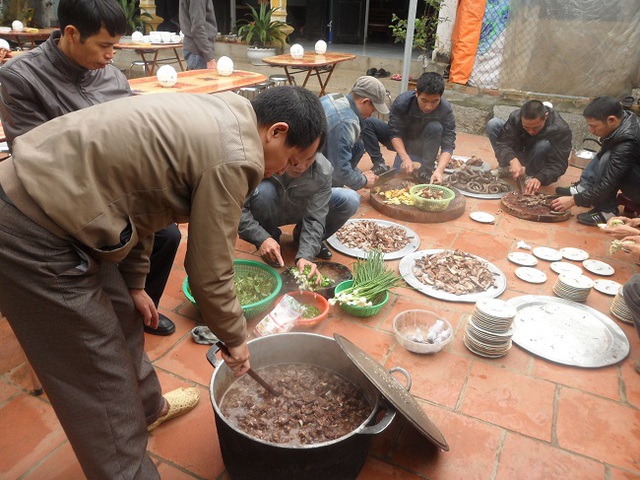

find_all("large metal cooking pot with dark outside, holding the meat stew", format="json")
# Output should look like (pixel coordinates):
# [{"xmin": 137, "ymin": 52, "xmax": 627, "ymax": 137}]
[{"xmin": 207, "ymin": 333, "xmax": 398, "ymax": 480}]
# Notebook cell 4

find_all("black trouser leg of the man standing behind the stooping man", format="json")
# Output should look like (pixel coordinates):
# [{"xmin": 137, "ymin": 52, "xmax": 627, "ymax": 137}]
[{"xmin": 144, "ymin": 223, "xmax": 181, "ymax": 307}]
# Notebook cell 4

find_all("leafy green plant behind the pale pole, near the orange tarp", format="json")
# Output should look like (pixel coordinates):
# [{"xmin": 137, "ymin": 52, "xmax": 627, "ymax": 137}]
[{"xmin": 389, "ymin": 0, "xmax": 446, "ymax": 72}]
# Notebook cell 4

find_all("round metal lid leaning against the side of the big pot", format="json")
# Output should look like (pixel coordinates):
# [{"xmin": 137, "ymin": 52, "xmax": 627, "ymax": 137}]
[{"xmin": 333, "ymin": 333, "xmax": 449, "ymax": 451}]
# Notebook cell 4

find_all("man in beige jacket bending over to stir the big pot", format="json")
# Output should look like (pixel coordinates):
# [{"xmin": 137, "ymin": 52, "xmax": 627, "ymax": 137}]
[{"xmin": 0, "ymin": 87, "xmax": 326, "ymax": 480}]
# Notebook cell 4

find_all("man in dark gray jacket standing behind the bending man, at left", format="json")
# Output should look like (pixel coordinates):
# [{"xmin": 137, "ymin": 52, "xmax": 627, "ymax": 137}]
[{"xmin": 0, "ymin": 0, "xmax": 181, "ymax": 335}]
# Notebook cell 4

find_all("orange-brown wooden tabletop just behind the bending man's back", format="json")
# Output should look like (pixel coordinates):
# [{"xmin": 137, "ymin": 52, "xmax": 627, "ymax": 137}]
[{"xmin": 129, "ymin": 69, "xmax": 267, "ymax": 95}]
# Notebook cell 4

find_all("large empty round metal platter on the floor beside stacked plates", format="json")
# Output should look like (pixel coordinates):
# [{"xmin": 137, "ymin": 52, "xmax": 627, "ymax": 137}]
[{"xmin": 507, "ymin": 295, "xmax": 629, "ymax": 368}]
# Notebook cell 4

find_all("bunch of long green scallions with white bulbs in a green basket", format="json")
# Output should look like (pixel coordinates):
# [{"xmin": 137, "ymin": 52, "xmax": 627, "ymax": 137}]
[{"xmin": 329, "ymin": 249, "xmax": 403, "ymax": 307}]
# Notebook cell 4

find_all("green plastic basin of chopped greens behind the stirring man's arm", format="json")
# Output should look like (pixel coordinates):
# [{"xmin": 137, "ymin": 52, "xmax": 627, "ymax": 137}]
[{"xmin": 182, "ymin": 259, "xmax": 282, "ymax": 318}]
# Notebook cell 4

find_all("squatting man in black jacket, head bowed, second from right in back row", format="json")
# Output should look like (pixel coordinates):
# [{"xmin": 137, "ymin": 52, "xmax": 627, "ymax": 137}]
[{"xmin": 487, "ymin": 100, "xmax": 571, "ymax": 193}]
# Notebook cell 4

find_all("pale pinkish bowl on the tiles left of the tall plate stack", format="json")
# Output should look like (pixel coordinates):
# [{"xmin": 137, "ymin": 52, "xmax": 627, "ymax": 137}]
[{"xmin": 393, "ymin": 309, "xmax": 453, "ymax": 353}]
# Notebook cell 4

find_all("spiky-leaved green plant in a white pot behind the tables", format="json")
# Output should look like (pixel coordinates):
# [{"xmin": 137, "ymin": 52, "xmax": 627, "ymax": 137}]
[{"xmin": 238, "ymin": 2, "xmax": 287, "ymax": 65}]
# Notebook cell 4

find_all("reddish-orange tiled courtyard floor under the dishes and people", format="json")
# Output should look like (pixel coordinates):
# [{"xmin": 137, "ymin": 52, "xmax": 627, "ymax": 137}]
[{"xmin": 0, "ymin": 134, "xmax": 640, "ymax": 480}]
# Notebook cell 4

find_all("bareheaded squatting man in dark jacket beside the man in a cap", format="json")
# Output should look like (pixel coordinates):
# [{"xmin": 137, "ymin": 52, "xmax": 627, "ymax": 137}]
[{"xmin": 361, "ymin": 72, "xmax": 456, "ymax": 183}]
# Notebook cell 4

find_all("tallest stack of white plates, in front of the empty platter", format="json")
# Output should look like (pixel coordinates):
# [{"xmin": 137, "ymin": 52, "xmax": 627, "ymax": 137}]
[{"xmin": 464, "ymin": 298, "xmax": 518, "ymax": 358}]
